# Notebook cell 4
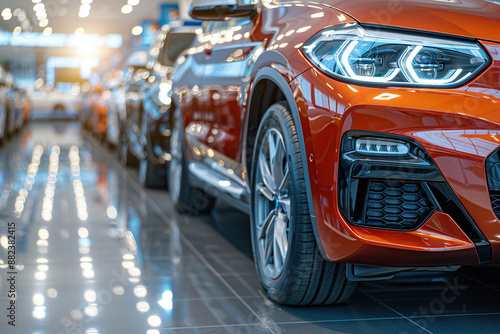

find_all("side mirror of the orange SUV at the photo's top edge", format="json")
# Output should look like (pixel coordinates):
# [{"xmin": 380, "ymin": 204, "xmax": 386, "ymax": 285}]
[{"xmin": 189, "ymin": 0, "xmax": 257, "ymax": 21}]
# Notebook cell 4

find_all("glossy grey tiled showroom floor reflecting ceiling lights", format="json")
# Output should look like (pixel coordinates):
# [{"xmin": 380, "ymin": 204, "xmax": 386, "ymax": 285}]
[{"xmin": 0, "ymin": 121, "xmax": 500, "ymax": 334}]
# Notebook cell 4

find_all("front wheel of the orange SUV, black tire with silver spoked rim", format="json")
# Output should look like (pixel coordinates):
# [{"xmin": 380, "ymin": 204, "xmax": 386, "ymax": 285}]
[{"xmin": 251, "ymin": 102, "xmax": 356, "ymax": 305}]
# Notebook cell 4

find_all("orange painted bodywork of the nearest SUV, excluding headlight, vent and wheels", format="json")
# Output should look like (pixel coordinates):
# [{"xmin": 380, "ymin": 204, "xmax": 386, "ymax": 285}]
[{"xmin": 174, "ymin": 1, "xmax": 500, "ymax": 266}]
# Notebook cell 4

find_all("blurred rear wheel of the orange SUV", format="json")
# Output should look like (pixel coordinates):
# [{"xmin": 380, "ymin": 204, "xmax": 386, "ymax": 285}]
[{"xmin": 168, "ymin": 111, "xmax": 215, "ymax": 215}]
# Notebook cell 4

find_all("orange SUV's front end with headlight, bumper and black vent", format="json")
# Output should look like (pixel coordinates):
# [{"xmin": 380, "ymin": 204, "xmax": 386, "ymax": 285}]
[{"xmin": 271, "ymin": 1, "xmax": 500, "ymax": 267}]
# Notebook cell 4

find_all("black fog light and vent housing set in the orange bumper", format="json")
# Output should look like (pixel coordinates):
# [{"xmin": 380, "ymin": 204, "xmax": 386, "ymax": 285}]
[{"xmin": 338, "ymin": 131, "xmax": 443, "ymax": 231}]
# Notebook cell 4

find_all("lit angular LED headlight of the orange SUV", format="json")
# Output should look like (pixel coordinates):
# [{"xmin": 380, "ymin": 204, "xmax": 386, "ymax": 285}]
[{"xmin": 302, "ymin": 23, "xmax": 490, "ymax": 87}]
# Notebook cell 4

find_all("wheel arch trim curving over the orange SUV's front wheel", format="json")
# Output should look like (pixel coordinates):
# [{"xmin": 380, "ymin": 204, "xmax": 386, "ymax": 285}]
[{"xmin": 242, "ymin": 67, "xmax": 329, "ymax": 261}]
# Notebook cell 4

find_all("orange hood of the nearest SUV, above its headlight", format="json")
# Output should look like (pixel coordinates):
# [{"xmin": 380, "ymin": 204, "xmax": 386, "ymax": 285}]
[{"xmin": 323, "ymin": 0, "xmax": 500, "ymax": 42}]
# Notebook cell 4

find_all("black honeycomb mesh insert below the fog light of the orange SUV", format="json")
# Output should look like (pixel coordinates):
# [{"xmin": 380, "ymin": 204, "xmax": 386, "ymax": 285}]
[{"xmin": 361, "ymin": 181, "xmax": 433, "ymax": 230}]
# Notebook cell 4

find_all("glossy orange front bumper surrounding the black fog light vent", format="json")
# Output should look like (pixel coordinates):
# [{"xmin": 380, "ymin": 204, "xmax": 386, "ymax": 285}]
[{"xmin": 291, "ymin": 41, "xmax": 500, "ymax": 266}]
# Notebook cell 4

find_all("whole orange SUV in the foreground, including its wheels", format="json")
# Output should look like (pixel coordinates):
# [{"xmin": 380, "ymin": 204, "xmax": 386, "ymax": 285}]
[{"xmin": 169, "ymin": 0, "xmax": 500, "ymax": 305}]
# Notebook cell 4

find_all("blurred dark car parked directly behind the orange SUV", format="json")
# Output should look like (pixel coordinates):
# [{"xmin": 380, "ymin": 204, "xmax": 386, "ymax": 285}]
[{"xmin": 122, "ymin": 25, "xmax": 201, "ymax": 187}]
